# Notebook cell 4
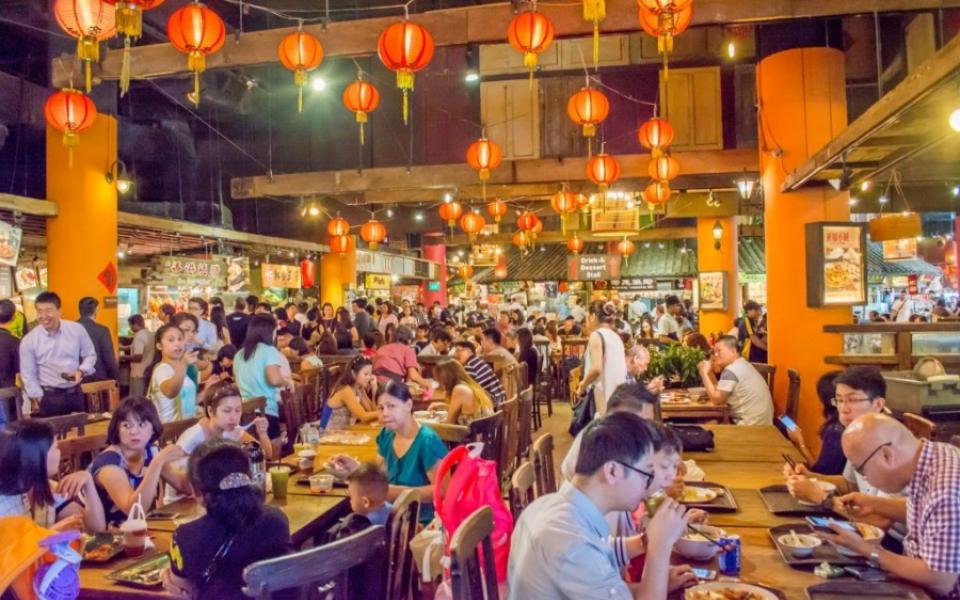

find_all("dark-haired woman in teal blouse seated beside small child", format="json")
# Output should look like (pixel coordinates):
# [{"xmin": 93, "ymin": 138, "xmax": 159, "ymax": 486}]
[{"xmin": 333, "ymin": 382, "xmax": 447, "ymax": 523}]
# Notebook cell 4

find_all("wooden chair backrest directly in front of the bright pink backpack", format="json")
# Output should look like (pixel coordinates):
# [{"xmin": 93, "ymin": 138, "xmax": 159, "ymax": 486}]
[{"xmin": 450, "ymin": 506, "xmax": 500, "ymax": 600}]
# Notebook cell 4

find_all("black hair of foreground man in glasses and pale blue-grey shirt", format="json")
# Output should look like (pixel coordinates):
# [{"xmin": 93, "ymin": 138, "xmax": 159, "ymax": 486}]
[{"xmin": 575, "ymin": 411, "xmax": 660, "ymax": 476}]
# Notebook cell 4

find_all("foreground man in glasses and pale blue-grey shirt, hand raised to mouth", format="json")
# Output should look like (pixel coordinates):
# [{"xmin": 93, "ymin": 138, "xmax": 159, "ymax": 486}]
[{"xmin": 507, "ymin": 412, "xmax": 690, "ymax": 600}]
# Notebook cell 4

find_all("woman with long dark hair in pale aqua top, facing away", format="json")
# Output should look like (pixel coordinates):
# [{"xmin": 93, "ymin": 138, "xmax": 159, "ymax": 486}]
[{"xmin": 233, "ymin": 315, "xmax": 293, "ymax": 438}]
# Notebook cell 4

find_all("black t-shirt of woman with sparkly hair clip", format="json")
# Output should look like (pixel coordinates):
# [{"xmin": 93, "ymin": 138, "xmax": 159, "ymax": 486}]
[{"xmin": 170, "ymin": 506, "xmax": 291, "ymax": 600}]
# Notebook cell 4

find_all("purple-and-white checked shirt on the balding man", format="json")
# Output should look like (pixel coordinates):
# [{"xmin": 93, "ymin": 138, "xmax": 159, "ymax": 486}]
[{"xmin": 904, "ymin": 442, "xmax": 960, "ymax": 600}]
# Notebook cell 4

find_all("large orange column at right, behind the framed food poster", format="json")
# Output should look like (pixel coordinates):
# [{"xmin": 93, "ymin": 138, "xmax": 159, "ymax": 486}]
[{"xmin": 757, "ymin": 48, "xmax": 850, "ymax": 448}]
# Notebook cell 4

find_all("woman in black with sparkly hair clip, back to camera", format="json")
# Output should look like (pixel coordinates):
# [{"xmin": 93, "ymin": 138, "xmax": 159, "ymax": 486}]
[{"xmin": 163, "ymin": 439, "xmax": 291, "ymax": 600}]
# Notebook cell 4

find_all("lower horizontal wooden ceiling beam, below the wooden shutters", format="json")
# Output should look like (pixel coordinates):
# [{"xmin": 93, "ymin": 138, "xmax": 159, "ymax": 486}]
[{"xmin": 230, "ymin": 149, "xmax": 758, "ymax": 203}]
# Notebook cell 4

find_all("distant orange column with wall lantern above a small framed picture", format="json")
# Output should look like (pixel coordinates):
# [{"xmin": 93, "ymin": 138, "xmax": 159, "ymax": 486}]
[{"xmin": 697, "ymin": 217, "xmax": 740, "ymax": 338}]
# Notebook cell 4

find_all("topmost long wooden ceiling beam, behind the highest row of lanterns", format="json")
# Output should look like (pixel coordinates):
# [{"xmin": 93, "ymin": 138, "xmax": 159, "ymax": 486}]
[{"xmin": 52, "ymin": 0, "xmax": 960, "ymax": 87}]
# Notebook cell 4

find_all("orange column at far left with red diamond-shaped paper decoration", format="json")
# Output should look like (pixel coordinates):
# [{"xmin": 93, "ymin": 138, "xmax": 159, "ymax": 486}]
[{"xmin": 47, "ymin": 114, "xmax": 118, "ymax": 344}]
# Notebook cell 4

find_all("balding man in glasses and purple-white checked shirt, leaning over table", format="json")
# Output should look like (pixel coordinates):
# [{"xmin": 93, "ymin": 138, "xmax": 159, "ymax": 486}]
[{"xmin": 823, "ymin": 414, "xmax": 960, "ymax": 600}]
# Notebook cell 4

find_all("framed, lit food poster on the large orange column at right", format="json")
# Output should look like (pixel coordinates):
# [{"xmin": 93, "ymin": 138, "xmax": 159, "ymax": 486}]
[{"xmin": 806, "ymin": 222, "xmax": 867, "ymax": 307}]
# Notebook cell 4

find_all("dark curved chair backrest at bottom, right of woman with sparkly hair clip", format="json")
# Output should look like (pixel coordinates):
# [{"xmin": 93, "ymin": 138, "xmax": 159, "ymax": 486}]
[{"xmin": 243, "ymin": 525, "xmax": 387, "ymax": 600}]
